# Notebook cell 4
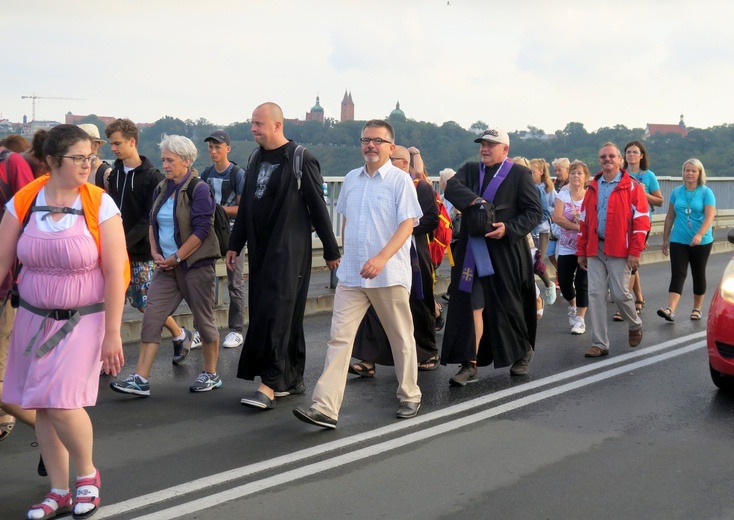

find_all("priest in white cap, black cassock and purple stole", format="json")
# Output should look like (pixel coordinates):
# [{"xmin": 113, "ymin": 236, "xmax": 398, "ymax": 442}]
[{"xmin": 441, "ymin": 128, "xmax": 543, "ymax": 386}]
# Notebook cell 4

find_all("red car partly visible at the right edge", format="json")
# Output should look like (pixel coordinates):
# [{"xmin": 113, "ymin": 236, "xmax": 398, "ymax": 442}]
[{"xmin": 706, "ymin": 228, "xmax": 734, "ymax": 390}]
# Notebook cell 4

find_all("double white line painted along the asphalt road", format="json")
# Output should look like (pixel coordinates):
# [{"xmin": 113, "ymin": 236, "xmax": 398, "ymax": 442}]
[{"xmin": 96, "ymin": 331, "xmax": 706, "ymax": 520}]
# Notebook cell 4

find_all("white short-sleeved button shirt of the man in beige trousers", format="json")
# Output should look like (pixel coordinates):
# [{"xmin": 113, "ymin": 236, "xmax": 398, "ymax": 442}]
[{"xmin": 336, "ymin": 161, "xmax": 423, "ymax": 291}]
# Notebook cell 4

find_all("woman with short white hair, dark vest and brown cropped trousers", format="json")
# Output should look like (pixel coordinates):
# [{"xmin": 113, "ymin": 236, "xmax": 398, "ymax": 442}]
[{"xmin": 110, "ymin": 135, "xmax": 222, "ymax": 396}]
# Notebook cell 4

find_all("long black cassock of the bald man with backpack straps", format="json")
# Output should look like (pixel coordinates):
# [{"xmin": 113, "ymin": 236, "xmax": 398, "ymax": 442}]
[{"xmin": 229, "ymin": 141, "xmax": 340, "ymax": 391}]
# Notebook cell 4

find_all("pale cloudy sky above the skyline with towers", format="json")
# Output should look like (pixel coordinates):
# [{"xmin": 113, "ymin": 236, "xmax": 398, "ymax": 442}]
[{"xmin": 0, "ymin": 0, "xmax": 734, "ymax": 133}]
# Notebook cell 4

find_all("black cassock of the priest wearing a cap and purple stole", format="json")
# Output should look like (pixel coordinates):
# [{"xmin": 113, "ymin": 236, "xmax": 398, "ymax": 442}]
[{"xmin": 441, "ymin": 163, "xmax": 543, "ymax": 368}]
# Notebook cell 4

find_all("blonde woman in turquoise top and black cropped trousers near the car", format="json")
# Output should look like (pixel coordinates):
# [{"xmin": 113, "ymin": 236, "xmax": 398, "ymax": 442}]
[{"xmin": 658, "ymin": 159, "xmax": 716, "ymax": 321}]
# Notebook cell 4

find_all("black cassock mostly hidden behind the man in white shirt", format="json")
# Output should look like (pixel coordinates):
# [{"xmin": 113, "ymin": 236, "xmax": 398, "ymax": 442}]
[{"xmin": 352, "ymin": 179, "xmax": 438, "ymax": 365}]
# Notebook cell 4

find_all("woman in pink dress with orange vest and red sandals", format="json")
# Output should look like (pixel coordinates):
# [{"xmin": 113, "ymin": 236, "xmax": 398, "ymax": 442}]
[{"xmin": 0, "ymin": 125, "xmax": 127, "ymax": 520}]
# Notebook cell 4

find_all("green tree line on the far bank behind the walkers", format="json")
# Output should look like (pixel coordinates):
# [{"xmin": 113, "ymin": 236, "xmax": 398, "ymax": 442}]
[{"xmin": 70, "ymin": 115, "xmax": 734, "ymax": 177}]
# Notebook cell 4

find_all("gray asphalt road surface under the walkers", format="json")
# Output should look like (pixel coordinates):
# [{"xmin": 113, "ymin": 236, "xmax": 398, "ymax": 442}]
[{"xmin": 0, "ymin": 234, "xmax": 734, "ymax": 520}]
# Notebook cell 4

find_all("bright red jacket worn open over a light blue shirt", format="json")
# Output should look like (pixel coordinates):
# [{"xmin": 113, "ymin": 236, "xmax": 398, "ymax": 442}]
[{"xmin": 576, "ymin": 170, "xmax": 650, "ymax": 258}]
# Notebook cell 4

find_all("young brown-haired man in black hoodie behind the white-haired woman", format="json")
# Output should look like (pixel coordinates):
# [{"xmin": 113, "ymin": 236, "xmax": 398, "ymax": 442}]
[{"xmin": 105, "ymin": 119, "xmax": 196, "ymax": 365}]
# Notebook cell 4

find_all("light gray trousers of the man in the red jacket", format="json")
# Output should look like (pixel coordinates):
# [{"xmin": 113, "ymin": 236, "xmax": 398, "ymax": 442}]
[{"xmin": 586, "ymin": 246, "xmax": 642, "ymax": 349}]
